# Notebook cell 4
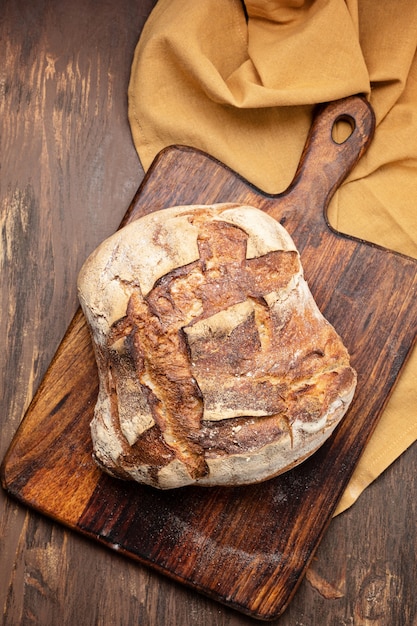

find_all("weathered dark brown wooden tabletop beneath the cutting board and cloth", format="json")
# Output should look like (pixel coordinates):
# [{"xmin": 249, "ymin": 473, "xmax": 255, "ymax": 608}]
[{"xmin": 0, "ymin": 0, "xmax": 417, "ymax": 626}]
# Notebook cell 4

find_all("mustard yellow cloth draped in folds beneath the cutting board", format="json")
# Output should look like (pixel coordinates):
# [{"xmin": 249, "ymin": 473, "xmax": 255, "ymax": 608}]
[{"xmin": 129, "ymin": 0, "xmax": 417, "ymax": 513}]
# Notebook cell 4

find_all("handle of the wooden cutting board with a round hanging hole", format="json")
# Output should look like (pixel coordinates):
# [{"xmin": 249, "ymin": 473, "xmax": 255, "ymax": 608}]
[{"xmin": 271, "ymin": 95, "xmax": 375, "ymax": 220}]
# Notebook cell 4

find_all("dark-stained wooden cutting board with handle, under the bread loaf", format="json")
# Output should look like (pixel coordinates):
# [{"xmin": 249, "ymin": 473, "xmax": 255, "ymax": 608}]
[{"xmin": 2, "ymin": 97, "xmax": 417, "ymax": 620}]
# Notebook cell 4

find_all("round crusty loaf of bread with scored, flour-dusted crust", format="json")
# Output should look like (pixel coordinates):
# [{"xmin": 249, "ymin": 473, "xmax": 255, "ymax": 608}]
[{"xmin": 78, "ymin": 204, "xmax": 356, "ymax": 489}]
